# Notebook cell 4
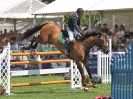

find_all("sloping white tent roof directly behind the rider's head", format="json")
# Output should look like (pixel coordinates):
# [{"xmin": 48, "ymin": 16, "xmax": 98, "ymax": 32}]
[{"xmin": 33, "ymin": 0, "xmax": 103, "ymax": 15}]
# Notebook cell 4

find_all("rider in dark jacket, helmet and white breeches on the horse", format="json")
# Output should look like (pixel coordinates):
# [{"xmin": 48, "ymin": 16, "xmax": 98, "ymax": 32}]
[{"xmin": 65, "ymin": 8, "xmax": 84, "ymax": 53}]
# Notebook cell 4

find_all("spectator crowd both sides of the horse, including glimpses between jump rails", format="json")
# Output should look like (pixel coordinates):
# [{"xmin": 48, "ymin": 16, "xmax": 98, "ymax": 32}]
[{"xmin": 0, "ymin": 23, "xmax": 133, "ymax": 69}]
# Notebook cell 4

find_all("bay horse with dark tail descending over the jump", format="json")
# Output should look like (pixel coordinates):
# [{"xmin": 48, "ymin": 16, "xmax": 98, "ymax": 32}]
[{"xmin": 21, "ymin": 22, "xmax": 109, "ymax": 88}]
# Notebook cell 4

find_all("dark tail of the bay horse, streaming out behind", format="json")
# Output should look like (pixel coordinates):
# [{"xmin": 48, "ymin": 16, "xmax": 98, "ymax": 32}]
[{"xmin": 21, "ymin": 23, "xmax": 46, "ymax": 40}]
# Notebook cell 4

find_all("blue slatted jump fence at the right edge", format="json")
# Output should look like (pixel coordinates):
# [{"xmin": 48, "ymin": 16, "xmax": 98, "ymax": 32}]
[{"xmin": 111, "ymin": 42, "xmax": 133, "ymax": 99}]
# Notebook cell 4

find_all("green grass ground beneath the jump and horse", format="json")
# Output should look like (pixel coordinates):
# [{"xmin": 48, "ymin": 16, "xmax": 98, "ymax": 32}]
[{"xmin": 0, "ymin": 75, "xmax": 111, "ymax": 99}]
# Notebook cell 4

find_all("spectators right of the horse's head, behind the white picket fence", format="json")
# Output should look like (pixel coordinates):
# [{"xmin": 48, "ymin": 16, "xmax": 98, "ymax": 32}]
[{"xmin": 95, "ymin": 23, "xmax": 133, "ymax": 52}]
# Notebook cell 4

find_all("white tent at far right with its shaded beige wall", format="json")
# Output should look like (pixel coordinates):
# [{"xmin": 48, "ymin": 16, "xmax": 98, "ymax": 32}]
[{"xmin": 85, "ymin": 0, "xmax": 133, "ymax": 31}]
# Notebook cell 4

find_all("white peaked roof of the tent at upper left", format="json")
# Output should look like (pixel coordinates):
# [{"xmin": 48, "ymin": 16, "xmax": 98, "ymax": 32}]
[{"xmin": 0, "ymin": 0, "xmax": 46, "ymax": 18}]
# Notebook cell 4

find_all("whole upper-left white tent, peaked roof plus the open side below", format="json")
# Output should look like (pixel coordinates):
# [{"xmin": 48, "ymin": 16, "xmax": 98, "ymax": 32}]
[{"xmin": 0, "ymin": 0, "xmax": 46, "ymax": 30}]
